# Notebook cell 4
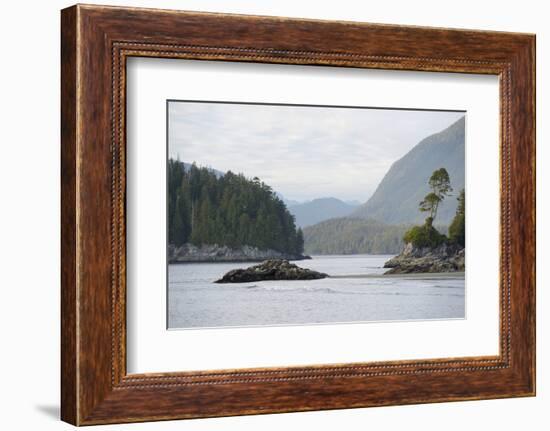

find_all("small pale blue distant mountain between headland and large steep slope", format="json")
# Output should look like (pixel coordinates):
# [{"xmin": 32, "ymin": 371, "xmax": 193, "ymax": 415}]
[{"xmin": 288, "ymin": 198, "xmax": 357, "ymax": 227}]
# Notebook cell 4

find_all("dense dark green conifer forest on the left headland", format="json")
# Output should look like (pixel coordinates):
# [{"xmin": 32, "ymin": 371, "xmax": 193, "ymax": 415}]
[{"xmin": 168, "ymin": 159, "xmax": 304, "ymax": 255}]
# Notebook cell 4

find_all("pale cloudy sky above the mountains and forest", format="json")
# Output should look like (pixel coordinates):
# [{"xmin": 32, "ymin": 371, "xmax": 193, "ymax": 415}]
[{"xmin": 168, "ymin": 101, "xmax": 464, "ymax": 202}]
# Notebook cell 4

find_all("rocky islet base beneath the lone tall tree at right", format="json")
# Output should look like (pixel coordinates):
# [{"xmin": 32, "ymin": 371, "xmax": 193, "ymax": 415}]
[{"xmin": 384, "ymin": 243, "xmax": 465, "ymax": 274}]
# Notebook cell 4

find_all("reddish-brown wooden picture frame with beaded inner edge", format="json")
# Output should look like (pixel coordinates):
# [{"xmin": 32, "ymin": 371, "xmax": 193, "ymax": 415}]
[{"xmin": 61, "ymin": 5, "xmax": 535, "ymax": 425}]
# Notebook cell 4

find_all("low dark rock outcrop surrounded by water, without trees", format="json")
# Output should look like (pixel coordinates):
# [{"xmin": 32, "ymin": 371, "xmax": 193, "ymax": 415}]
[{"xmin": 216, "ymin": 259, "xmax": 328, "ymax": 283}]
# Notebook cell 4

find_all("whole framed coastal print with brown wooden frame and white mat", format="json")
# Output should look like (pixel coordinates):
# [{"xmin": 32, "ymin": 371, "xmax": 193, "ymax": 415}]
[{"xmin": 61, "ymin": 5, "xmax": 535, "ymax": 425}]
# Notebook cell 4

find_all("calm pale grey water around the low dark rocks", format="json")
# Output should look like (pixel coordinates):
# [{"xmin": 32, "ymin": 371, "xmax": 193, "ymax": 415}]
[{"xmin": 168, "ymin": 255, "xmax": 465, "ymax": 329}]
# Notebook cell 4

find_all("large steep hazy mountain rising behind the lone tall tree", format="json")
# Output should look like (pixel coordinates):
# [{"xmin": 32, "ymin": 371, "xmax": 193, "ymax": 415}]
[{"xmin": 351, "ymin": 117, "xmax": 465, "ymax": 225}]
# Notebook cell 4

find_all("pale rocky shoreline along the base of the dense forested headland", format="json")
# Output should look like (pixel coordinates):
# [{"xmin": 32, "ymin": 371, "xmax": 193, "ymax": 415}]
[{"xmin": 168, "ymin": 244, "xmax": 311, "ymax": 263}]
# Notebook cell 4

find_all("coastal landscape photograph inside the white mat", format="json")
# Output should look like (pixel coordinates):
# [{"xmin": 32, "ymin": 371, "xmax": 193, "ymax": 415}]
[{"xmin": 167, "ymin": 100, "xmax": 468, "ymax": 329}]
